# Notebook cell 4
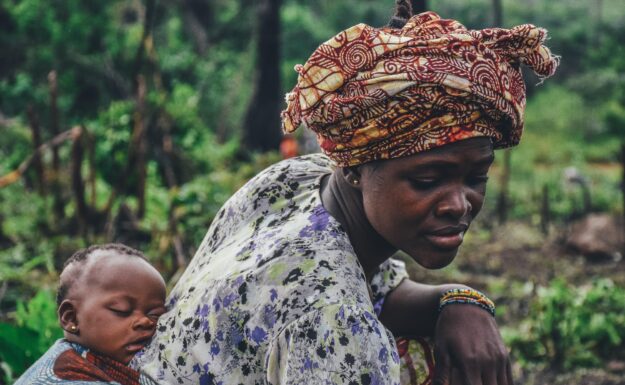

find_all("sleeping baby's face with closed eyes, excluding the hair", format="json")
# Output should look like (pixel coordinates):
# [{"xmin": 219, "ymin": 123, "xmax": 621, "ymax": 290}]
[{"xmin": 71, "ymin": 250, "xmax": 166, "ymax": 364}]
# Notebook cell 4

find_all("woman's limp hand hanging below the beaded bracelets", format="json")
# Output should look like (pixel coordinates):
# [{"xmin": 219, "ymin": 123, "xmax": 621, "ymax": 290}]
[{"xmin": 433, "ymin": 304, "xmax": 513, "ymax": 385}]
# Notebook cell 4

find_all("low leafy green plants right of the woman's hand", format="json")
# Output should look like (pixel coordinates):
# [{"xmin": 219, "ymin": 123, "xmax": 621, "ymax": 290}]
[{"xmin": 503, "ymin": 279, "xmax": 625, "ymax": 369}]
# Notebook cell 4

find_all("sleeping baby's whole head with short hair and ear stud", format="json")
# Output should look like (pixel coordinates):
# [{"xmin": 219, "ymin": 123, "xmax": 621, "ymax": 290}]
[{"xmin": 57, "ymin": 244, "xmax": 166, "ymax": 364}]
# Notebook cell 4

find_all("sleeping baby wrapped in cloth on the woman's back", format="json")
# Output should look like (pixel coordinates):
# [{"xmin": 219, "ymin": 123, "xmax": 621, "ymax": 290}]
[{"xmin": 15, "ymin": 244, "xmax": 166, "ymax": 385}]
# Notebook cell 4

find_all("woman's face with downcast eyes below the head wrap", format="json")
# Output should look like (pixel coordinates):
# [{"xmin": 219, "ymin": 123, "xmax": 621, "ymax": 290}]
[{"xmin": 360, "ymin": 138, "xmax": 494, "ymax": 269}]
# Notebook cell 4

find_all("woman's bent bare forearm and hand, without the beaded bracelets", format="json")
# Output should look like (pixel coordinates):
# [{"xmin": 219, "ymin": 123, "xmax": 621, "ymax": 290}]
[{"xmin": 380, "ymin": 279, "xmax": 513, "ymax": 385}]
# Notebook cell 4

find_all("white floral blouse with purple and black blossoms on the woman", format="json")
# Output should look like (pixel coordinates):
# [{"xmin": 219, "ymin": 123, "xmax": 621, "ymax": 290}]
[{"xmin": 133, "ymin": 154, "xmax": 407, "ymax": 385}]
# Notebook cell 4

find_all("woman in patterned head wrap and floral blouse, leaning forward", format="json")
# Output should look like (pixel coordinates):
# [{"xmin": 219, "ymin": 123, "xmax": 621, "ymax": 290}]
[{"xmin": 135, "ymin": 1, "xmax": 557, "ymax": 385}]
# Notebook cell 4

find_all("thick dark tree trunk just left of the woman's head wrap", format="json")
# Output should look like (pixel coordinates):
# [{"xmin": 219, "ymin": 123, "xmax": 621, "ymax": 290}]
[{"xmin": 243, "ymin": 0, "xmax": 282, "ymax": 151}]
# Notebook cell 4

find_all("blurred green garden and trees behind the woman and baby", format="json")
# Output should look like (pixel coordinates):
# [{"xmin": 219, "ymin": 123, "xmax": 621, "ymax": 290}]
[{"xmin": 0, "ymin": 0, "xmax": 625, "ymax": 384}]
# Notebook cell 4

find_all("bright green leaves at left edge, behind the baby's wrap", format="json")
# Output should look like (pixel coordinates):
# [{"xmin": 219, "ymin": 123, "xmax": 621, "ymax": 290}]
[{"xmin": 0, "ymin": 291, "xmax": 63, "ymax": 383}]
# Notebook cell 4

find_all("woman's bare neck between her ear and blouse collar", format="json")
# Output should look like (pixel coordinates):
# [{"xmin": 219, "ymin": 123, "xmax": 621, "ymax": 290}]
[{"xmin": 321, "ymin": 169, "xmax": 397, "ymax": 281}]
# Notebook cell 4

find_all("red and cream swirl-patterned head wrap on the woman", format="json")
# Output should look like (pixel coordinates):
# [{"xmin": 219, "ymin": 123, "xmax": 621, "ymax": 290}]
[{"xmin": 282, "ymin": 12, "xmax": 558, "ymax": 166}]
